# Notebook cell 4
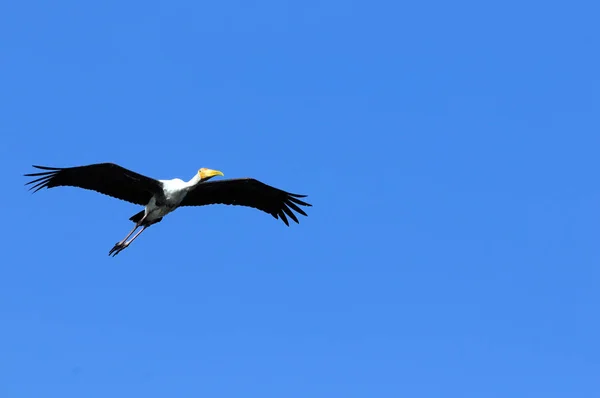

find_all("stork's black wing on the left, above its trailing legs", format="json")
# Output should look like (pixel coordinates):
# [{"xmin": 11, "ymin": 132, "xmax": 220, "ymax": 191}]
[{"xmin": 25, "ymin": 163, "xmax": 162, "ymax": 205}]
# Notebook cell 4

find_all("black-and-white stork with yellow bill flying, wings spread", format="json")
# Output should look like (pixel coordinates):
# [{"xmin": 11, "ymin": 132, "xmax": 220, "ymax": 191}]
[{"xmin": 24, "ymin": 162, "xmax": 312, "ymax": 257}]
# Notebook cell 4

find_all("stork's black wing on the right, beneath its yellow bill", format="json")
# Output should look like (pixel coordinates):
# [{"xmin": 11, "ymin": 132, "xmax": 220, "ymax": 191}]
[{"xmin": 181, "ymin": 178, "xmax": 312, "ymax": 226}]
